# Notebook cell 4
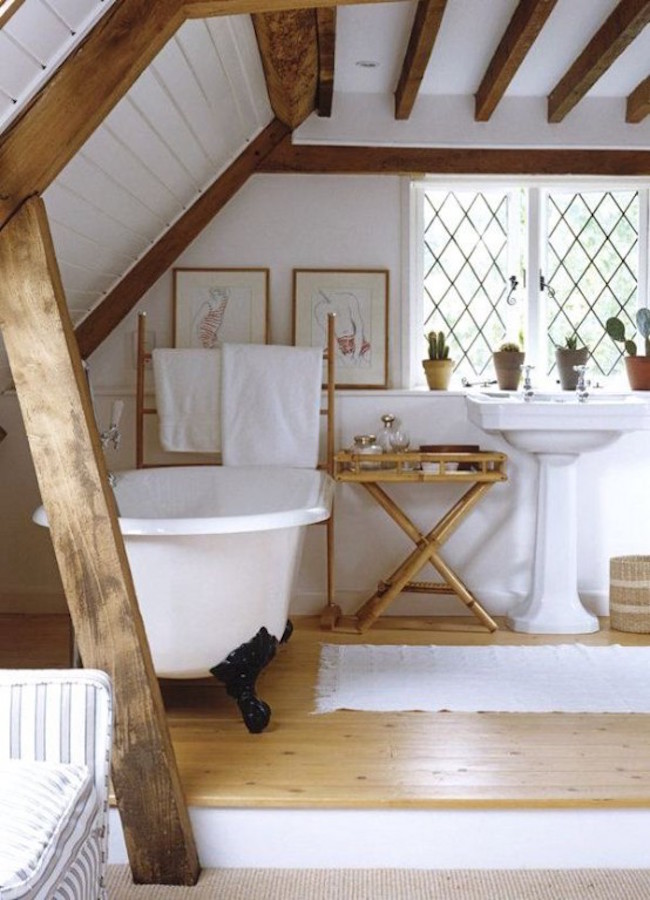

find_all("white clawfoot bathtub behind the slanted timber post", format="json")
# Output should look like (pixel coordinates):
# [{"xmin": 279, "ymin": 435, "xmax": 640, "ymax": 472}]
[{"xmin": 34, "ymin": 466, "xmax": 334, "ymax": 730}]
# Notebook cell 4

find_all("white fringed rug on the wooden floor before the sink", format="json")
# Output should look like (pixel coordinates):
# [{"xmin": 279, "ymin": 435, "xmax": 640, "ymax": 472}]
[{"xmin": 316, "ymin": 644, "xmax": 650, "ymax": 713}]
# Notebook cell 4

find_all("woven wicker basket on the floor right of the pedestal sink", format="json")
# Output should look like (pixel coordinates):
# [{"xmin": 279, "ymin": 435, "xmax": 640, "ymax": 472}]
[{"xmin": 609, "ymin": 556, "xmax": 650, "ymax": 634}]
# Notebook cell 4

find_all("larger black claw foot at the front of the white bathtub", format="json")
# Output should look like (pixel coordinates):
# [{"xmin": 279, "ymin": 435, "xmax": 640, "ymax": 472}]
[{"xmin": 210, "ymin": 628, "xmax": 278, "ymax": 734}]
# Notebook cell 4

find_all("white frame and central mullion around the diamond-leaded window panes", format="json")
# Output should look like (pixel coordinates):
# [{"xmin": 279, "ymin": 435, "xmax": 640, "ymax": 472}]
[{"xmin": 403, "ymin": 175, "xmax": 650, "ymax": 391}]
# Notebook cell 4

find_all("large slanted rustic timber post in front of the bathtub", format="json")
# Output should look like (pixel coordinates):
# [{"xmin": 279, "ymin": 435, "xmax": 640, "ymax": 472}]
[{"xmin": 0, "ymin": 197, "xmax": 199, "ymax": 885}]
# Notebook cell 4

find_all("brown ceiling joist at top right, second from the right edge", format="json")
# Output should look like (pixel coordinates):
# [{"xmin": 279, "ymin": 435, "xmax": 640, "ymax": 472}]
[{"xmin": 548, "ymin": 0, "xmax": 650, "ymax": 122}]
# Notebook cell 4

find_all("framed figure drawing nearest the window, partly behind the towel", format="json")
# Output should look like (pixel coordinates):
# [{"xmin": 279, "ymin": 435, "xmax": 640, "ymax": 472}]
[{"xmin": 293, "ymin": 269, "xmax": 388, "ymax": 388}]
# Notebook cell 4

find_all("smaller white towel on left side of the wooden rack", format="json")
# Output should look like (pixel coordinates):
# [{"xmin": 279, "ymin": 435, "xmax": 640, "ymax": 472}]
[{"xmin": 152, "ymin": 349, "xmax": 221, "ymax": 453}]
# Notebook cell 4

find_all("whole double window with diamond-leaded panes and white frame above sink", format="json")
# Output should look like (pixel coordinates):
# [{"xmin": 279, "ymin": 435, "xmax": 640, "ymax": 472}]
[{"xmin": 407, "ymin": 179, "xmax": 650, "ymax": 390}]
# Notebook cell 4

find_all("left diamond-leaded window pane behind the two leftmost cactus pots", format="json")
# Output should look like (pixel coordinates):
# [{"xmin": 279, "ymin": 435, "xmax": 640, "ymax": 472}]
[{"xmin": 423, "ymin": 190, "xmax": 513, "ymax": 377}]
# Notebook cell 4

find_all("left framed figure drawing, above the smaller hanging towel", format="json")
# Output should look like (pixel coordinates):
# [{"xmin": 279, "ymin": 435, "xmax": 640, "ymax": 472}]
[{"xmin": 173, "ymin": 269, "xmax": 269, "ymax": 350}]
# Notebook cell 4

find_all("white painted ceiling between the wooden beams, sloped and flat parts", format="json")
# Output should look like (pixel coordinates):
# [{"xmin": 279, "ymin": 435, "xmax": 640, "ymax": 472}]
[{"xmin": 0, "ymin": 0, "xmax": 650, "ymax": 384}]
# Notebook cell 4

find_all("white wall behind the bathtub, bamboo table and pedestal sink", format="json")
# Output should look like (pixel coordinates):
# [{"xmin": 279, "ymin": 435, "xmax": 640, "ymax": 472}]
[{"xmin": 0, "ymin": 175, "xmax": 650, "ymax": 614}]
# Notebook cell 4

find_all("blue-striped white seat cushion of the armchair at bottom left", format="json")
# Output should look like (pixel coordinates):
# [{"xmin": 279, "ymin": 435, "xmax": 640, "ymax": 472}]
[{"xmin": 0, "ymin": 760, "xmax": 102, "ymax": 900}]
